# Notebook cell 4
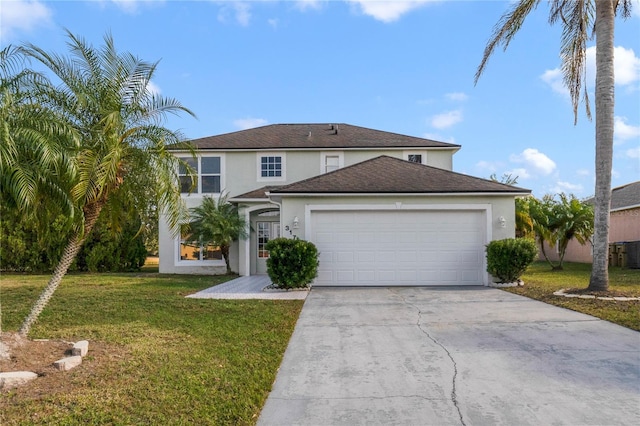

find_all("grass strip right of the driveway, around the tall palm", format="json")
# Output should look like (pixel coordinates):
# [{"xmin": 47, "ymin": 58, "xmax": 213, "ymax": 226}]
[{"xmin": 505, "ymin": 262, "xmax": 640, "ymax": 331}]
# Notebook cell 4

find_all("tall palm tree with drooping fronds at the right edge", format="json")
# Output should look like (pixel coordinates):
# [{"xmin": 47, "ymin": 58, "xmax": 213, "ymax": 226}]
[{"xmin": 475, "ymin": 0, "xmax": 632, "ymax": 291}]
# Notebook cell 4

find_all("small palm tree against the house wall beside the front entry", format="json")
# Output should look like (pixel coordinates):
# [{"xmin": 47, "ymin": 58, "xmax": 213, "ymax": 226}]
[{"xmin": 184, "ymin": 194, "xmax": 248, "ymax": 274}]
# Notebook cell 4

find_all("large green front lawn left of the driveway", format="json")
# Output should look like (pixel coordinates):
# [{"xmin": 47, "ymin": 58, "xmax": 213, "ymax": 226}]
[{"xmin": 0, "ymin": 273, "xmax": 303, "ymax": 425}]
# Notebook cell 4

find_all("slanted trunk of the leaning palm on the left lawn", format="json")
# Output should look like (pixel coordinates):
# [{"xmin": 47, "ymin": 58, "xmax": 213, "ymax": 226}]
[{"xmin": 18, "ymin": 202, "xmax": 104, "ymax": 337}]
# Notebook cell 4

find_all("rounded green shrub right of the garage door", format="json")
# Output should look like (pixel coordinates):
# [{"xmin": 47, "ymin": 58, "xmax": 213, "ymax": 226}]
[{"xmin": 487, "ymin": 238, "xmax": 538, "ymax": 283}]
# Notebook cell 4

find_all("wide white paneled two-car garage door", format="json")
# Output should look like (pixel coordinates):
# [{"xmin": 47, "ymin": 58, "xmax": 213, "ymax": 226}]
[{"xmin": 310, "ymin": 210, "xmax": 486, "ymax": 286}]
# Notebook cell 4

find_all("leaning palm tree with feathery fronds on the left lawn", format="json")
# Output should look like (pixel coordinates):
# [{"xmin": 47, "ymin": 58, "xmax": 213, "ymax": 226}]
[{"xmin": 19, "ymin": 31, "xmax": 193, "ymax": 336}]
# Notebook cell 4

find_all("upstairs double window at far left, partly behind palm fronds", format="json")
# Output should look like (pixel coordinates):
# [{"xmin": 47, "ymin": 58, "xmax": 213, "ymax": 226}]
[{"xmin": 178, "ymin": 157, "xmax": 222, "ymax": 194}]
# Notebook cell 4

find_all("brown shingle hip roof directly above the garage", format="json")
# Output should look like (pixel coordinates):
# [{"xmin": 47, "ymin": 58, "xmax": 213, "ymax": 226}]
[{"xmin": 271, "ymin": 155, "xmax": 531, "ymax": 195}]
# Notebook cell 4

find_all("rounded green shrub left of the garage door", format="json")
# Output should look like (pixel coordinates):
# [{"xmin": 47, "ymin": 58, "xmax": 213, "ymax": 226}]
[{"xmin": 266, "ymin": 238, "xmax": 318, "ymax": 289}]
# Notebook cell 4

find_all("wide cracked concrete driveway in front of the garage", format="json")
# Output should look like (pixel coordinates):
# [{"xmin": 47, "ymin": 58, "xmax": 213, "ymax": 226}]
[{"xmin": 258, "ymin": 287, "xmax": 640, "ymax": 425}]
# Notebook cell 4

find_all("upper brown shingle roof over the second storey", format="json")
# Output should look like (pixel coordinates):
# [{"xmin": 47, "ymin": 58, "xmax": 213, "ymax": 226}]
[{"xmin": 180, "ymin": 124, "xmax": 460, "ymax": 151}]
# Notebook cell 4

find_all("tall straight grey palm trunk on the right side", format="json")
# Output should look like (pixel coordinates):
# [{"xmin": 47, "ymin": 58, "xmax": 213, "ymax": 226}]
[{"xmin": 589, "ymin": 0, "xmax": 615, "ymax": 291}]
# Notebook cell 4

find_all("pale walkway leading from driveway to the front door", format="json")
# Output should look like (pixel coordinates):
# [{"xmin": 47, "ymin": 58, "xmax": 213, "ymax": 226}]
[{"xmin": 186, "ymin": 275, "xmax": 309, "ymax": 300}]
